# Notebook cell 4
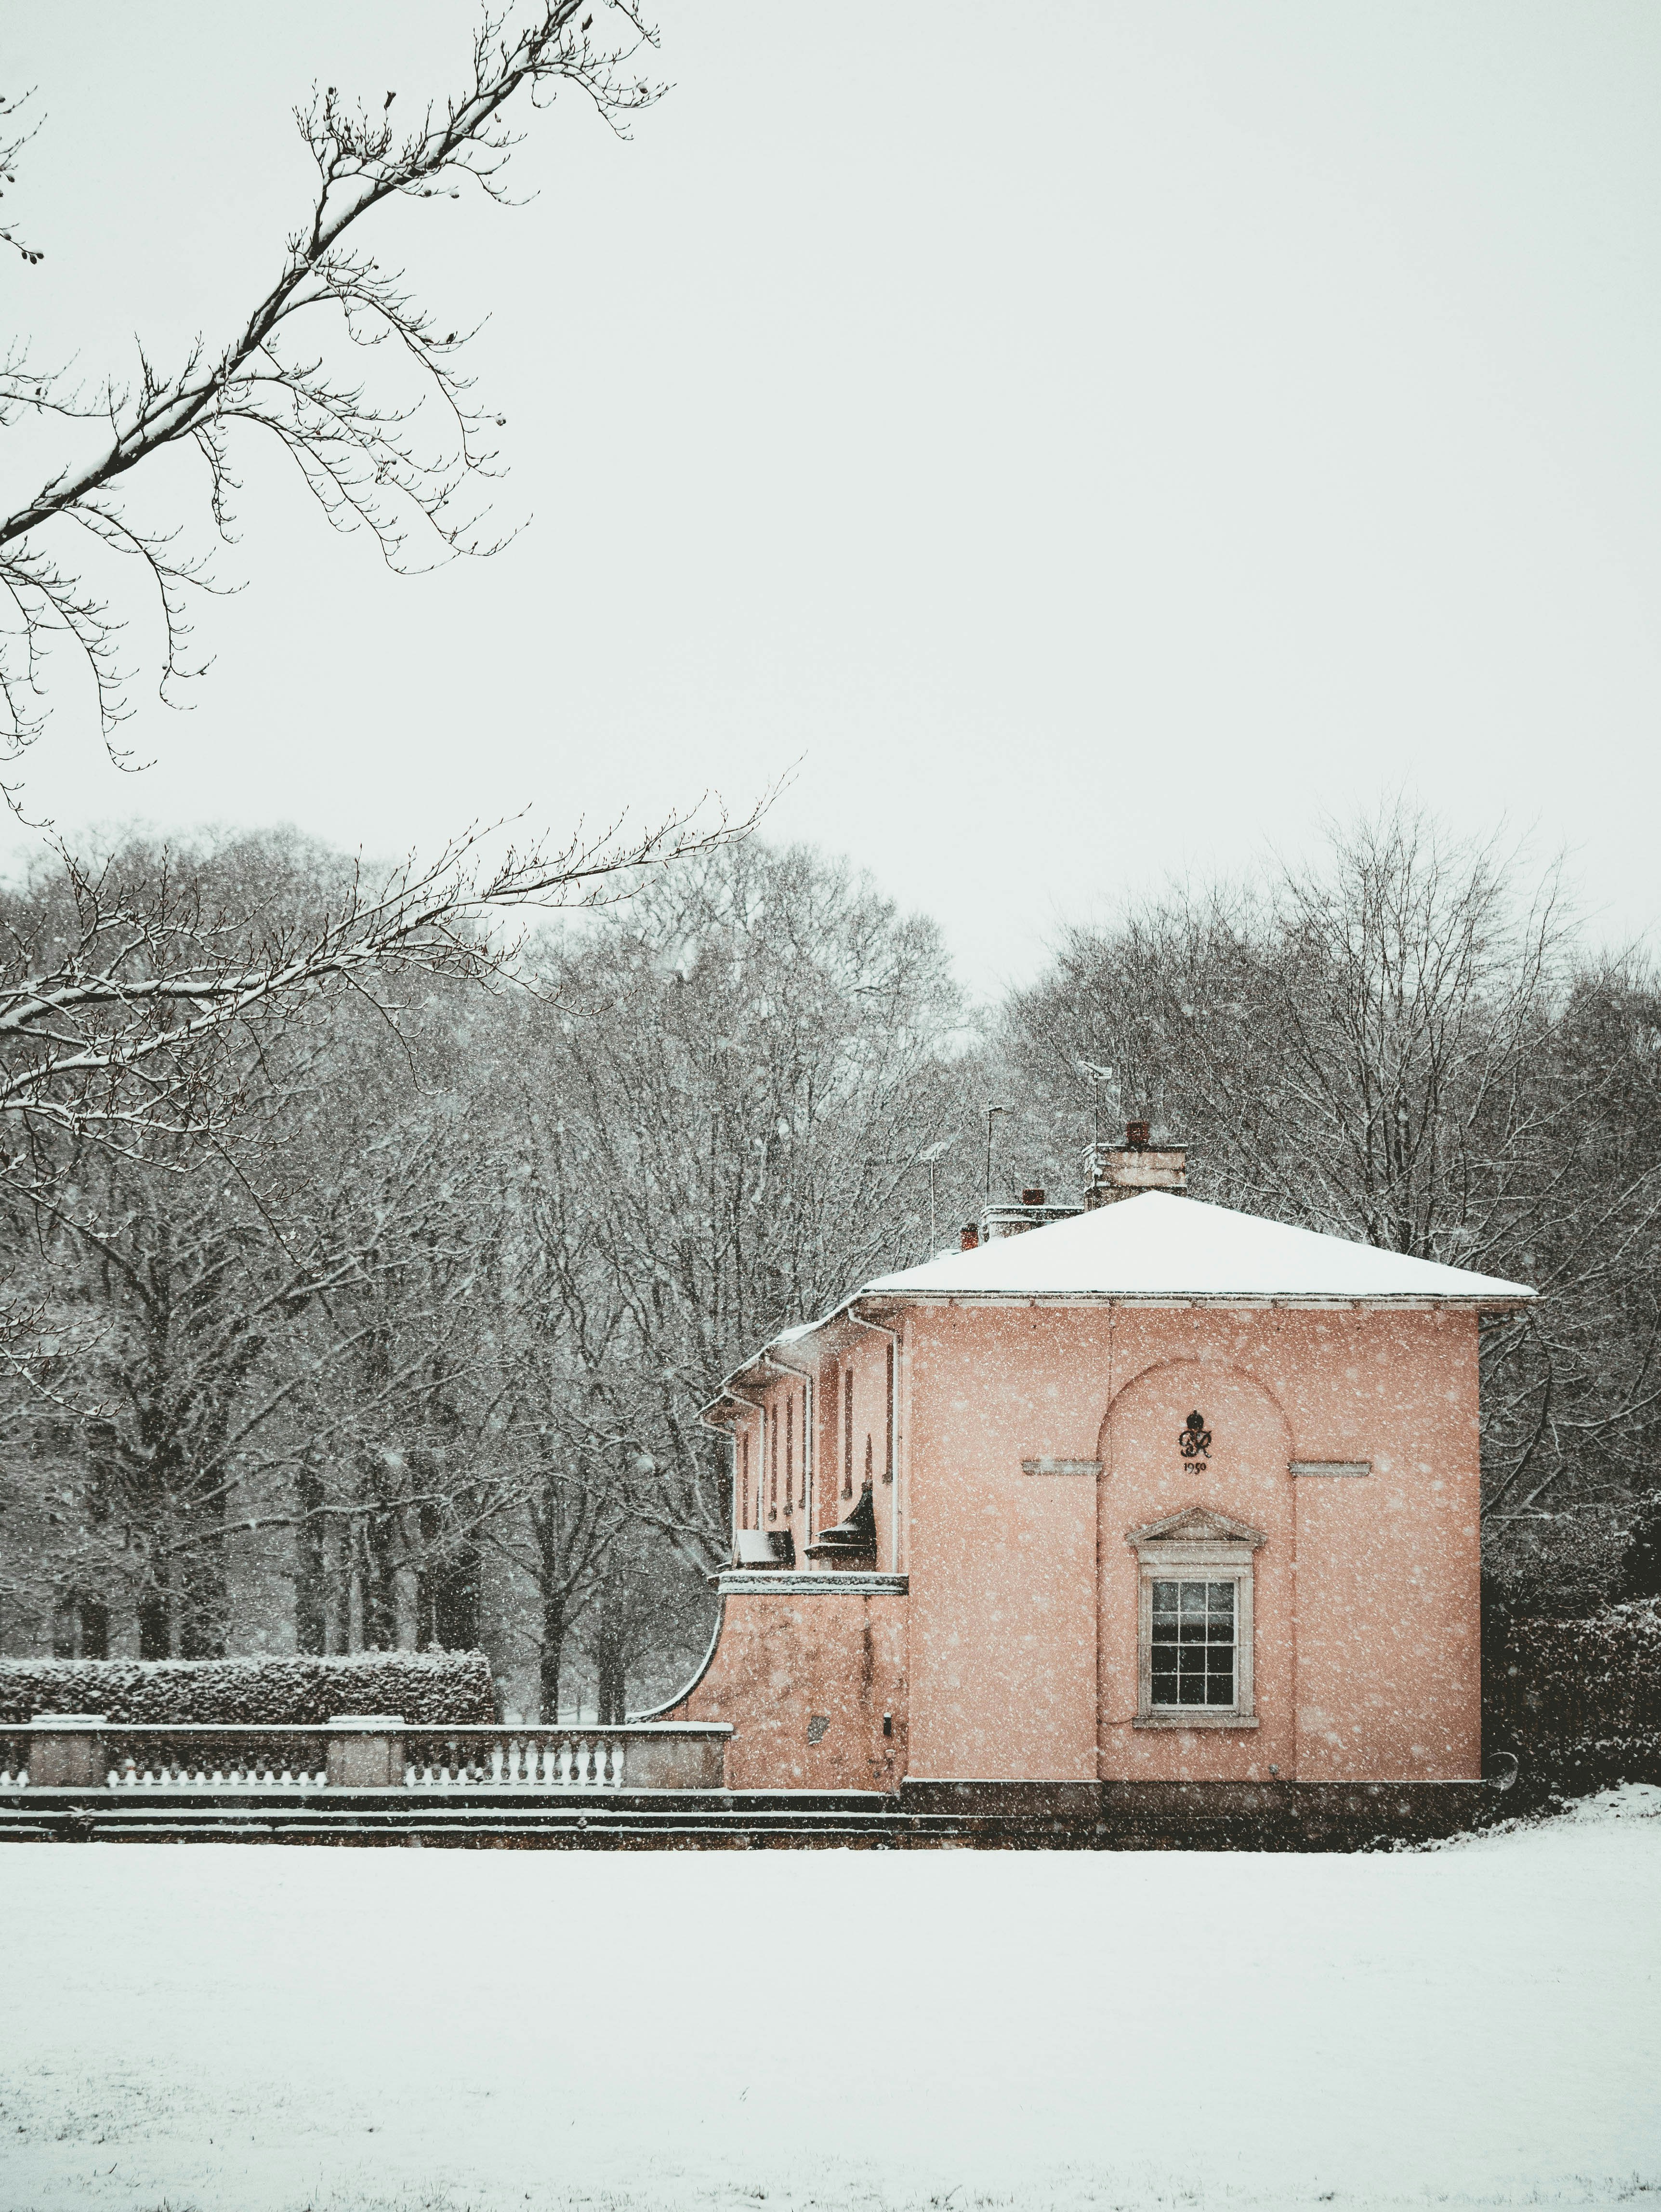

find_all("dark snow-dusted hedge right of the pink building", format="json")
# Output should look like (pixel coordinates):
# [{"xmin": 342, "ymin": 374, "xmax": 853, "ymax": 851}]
[{"xmin": 1486, "ymin": 1597, "xmax": 1661, "ymax": 1785}]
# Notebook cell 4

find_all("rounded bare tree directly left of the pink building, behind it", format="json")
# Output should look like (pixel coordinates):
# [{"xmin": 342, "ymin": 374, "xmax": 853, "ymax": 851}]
[{"xmin": 524, "ymin": 843, "xmax": 969, "ymax": 1566}]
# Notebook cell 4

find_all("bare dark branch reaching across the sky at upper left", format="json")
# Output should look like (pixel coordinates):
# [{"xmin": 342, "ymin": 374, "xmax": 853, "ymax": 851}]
[{"xmin": 0, "ymin": 0, "xmax": 655, "ymax": 778}]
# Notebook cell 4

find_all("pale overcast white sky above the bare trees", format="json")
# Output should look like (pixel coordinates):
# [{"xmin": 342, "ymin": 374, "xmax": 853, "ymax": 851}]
[{"xmin": 2, "ymin": 0, "xmax": 1661, "ymax": 989}]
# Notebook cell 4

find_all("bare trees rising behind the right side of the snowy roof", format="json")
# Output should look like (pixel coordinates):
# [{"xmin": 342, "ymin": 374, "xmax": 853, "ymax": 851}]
[{"xmin": 1006, "ymin": 807, "xmax": 1661, "ymax": 1557}]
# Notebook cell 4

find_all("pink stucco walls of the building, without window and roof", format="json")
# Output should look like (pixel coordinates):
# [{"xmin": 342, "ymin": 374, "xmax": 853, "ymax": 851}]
[{"xmin": 685, "ymin": 1305, "xmax": 1482, "ymax": 1787}]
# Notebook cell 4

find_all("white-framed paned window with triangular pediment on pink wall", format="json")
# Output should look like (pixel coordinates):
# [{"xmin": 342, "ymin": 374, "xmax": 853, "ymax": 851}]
[{"xmin": 1126, "ymin": 1506, "xmax": 1265, "ymax": 1727}]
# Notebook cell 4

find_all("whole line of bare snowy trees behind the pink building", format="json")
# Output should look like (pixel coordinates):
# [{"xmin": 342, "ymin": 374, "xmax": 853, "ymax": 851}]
[{"xmin": 0, "ymin": 810, "xmax": 1661, "ymax": 1719}]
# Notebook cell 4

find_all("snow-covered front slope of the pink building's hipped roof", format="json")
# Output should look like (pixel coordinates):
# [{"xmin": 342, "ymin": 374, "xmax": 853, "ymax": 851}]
[{"xmin": 860, "ymin": 1190, "xmax": 1535, "ymax": 1307}]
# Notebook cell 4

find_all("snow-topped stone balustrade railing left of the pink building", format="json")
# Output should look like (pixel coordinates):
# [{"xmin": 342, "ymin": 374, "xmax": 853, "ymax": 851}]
[{"xmin": 0, "ymin": 1712, "xmax": 732, "ymax": 1794}]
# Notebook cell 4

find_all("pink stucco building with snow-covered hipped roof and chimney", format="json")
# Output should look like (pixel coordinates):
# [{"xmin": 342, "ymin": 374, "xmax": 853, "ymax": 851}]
[{"xmin": 674, "ymin": 1126, "xmax": 1533, "ymax": 1792}]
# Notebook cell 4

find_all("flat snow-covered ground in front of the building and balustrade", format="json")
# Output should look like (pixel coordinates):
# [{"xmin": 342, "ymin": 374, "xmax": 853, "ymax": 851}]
[{"xmin": 0, "ymin": 1790, "xmax": 1661, "ymax": 2212}]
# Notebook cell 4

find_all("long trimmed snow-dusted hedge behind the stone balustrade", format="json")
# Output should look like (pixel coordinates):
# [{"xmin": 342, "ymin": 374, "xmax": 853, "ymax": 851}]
[{"xmin": 0, "ymin": 1652, "xmax": 495, "ymax": 1727}]
